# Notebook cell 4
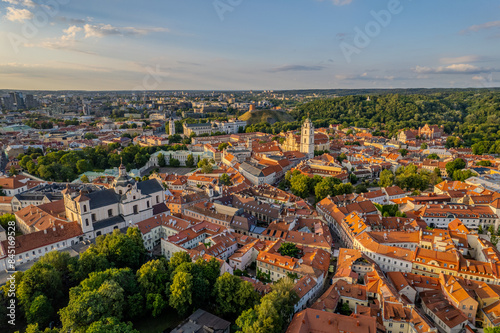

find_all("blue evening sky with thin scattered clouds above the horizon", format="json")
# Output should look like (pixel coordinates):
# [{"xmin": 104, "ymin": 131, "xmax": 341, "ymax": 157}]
[{"xmin": 0, "ymin": 0, "xmax": 500, "ymax": 90}]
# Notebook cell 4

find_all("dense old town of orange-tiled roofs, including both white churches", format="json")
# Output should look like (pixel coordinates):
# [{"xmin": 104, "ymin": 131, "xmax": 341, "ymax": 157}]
[{"xmin": 0, "ymin": 120, "xmax": 500, "ymax": 333}]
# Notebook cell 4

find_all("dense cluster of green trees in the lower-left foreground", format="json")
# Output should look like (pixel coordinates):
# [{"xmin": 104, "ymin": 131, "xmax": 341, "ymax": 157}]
[{"xmin": 0, "ymin": 227, "xmax": 297, "ymax": 333}]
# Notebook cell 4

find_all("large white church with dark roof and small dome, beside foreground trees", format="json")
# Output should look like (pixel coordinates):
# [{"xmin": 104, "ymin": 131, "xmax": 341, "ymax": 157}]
[{"xmin": 62, "ymin": 165, "xmax": 168, "ymax": 239}]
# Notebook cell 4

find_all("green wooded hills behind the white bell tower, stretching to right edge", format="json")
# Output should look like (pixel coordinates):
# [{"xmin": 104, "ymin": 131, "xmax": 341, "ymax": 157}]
[{"xmin": 246, "ymin": 89, "xmax": 500, "ymax": 153}]
